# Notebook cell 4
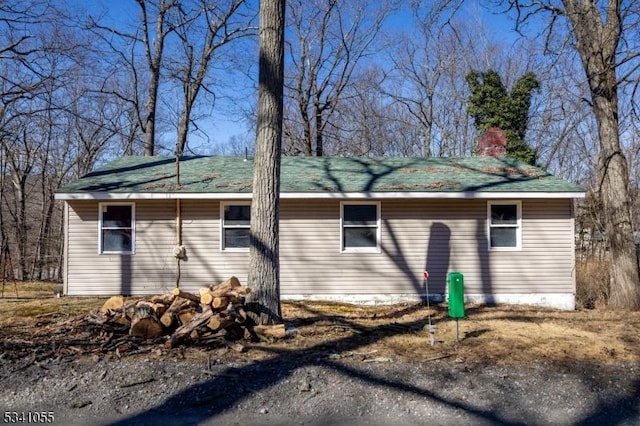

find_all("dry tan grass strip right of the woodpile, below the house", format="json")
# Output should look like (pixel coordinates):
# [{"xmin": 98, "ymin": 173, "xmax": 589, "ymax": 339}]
[{"xmin": 264, "ymin": 303, "xmax": 640, "ymax": 364}]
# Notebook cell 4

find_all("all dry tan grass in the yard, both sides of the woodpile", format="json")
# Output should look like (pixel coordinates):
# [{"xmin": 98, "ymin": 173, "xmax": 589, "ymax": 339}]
[{"xmin": 0, "ymin": 283, "xmax": 640, "ymax": 364}]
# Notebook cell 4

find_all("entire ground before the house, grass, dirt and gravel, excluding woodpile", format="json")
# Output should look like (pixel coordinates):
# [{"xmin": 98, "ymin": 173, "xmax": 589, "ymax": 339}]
[{"xmin": 0, "ymin": 283, "xmax": 640, "ymax": 425}]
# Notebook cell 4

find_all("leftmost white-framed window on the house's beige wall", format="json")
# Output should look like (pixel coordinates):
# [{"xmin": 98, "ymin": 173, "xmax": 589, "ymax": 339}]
[{"xmin": 99, "ymin": 203, "xmax": 135, "ymax": 254}]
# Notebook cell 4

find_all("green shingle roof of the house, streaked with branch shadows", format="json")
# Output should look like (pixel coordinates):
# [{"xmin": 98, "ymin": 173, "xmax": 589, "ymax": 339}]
[{"xmin": 57, "ymin": 157, "xmax": 583, "ymax": 195}]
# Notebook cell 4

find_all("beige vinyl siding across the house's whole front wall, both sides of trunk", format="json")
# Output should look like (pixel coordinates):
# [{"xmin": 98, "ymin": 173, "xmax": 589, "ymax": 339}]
[{"xmin": 67, "ymin": 199, "xmax": 574, "ymax": 297}]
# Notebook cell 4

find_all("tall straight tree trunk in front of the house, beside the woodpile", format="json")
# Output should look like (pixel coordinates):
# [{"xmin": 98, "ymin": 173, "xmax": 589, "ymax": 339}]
[{"xmin": 247, "ymin": 0, "xmax": 285, "ymax": 324}]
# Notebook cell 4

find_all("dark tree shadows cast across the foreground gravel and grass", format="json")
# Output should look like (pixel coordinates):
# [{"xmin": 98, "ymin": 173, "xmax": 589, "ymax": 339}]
[{"xmin": 111, "ymin": 302, "xmax": 640, "ymax": 426}]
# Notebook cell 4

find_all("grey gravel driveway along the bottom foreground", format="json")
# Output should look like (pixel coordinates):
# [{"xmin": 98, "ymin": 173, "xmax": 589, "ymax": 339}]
[{"xmin": 0, "ymin": 354, "xmax": 640, "ymax": 425}]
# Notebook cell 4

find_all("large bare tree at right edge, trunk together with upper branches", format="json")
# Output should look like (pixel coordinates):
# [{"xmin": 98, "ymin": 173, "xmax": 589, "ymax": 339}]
[{"xmin": 508, "ymin": 0, "xmax": 640, "ymax": 309}]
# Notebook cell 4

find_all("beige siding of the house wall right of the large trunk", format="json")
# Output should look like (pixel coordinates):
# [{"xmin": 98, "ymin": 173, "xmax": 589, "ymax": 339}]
[{"xmin": 281, "ymin": 200, "xmax": 574, "ymax": 295}]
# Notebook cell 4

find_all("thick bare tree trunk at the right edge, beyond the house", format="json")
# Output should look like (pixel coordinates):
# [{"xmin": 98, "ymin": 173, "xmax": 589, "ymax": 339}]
[{"xmin": 563, "ymin": 0, "xmax": 640, "ymax": 309}]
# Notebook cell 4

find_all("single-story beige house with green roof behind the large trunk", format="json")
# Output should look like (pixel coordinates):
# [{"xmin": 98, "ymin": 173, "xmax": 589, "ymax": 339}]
[{"xmin": 56, "ymin": 131, "xmax": 584, "ymax": 309}]
